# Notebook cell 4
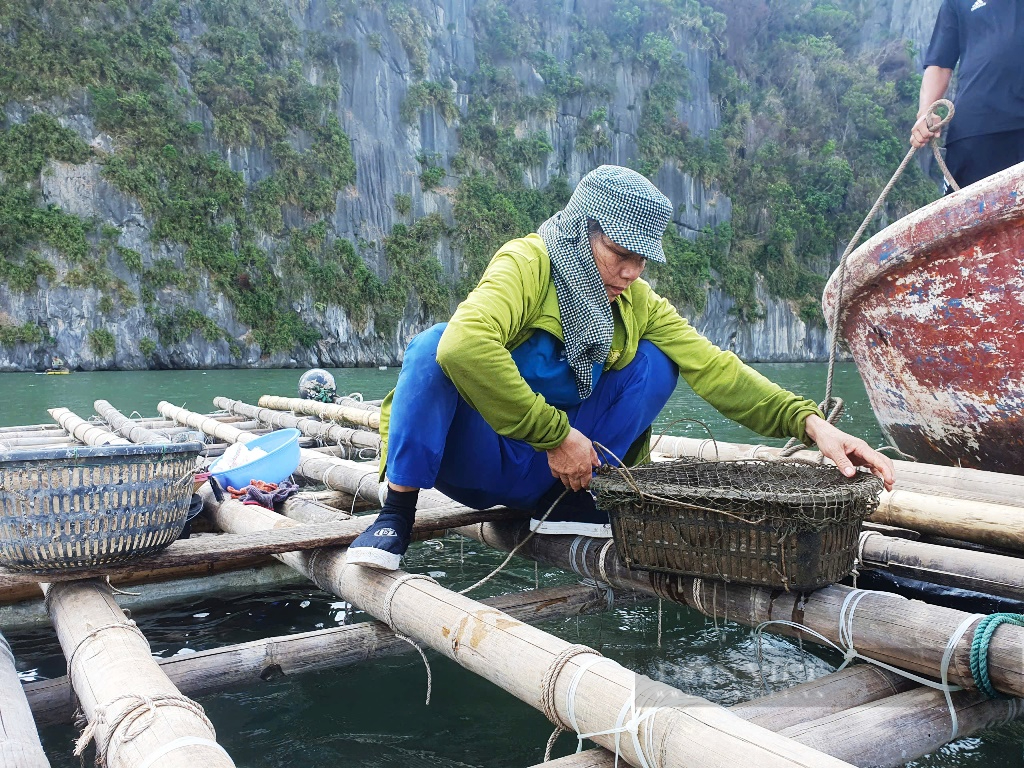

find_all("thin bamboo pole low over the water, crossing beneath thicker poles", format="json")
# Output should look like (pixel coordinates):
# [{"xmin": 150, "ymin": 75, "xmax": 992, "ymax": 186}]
[{"xmin": 25, "ymin": 571, "xmax": 635, "ymax": 729}]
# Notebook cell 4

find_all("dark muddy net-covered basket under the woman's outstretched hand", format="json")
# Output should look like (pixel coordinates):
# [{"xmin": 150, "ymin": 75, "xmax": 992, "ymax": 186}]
[{"xmin": 591, "ymin": 460, "xmax": 882, "ymax": 591}]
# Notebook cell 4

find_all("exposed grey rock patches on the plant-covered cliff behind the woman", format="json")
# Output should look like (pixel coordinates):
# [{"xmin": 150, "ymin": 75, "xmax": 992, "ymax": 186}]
[{"xmin": 0, "ymin": 0, "xmax": 938, "ymax": 371}]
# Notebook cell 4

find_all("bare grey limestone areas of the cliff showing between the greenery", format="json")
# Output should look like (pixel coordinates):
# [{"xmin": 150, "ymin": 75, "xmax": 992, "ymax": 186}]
[{"xmin": 0, "ymin": 0, "xmax": 937, "ymax": 371}]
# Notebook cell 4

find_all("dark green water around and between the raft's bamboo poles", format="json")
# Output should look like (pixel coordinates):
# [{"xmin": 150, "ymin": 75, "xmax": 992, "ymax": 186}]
[{"xmin": 0, "ymin": 364, "xmax": 1024, "ymax": 768}]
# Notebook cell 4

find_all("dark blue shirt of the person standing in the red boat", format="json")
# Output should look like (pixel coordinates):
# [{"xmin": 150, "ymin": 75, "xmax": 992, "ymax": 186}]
[{"xmin": 925, "ymin": 0, "xmax": 1024, "ymax": 142}]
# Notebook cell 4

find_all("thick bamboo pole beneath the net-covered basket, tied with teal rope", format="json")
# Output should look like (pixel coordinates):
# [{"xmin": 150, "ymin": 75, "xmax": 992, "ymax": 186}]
[{"xmin": 459, "ymin": 523, "xmax": 1024, "ymax": 696}]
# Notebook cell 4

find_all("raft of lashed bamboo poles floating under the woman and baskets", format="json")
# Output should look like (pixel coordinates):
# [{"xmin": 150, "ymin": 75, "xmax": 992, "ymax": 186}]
[{"xmin": 0, "ymin": 396, "xmax": 1024, "ymax": 768}]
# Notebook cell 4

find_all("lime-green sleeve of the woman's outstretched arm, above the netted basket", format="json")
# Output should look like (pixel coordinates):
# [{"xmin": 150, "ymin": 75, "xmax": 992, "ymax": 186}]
[{"xmin": 642, "ymin": 291, "xmax": 821, "ymax": 440}]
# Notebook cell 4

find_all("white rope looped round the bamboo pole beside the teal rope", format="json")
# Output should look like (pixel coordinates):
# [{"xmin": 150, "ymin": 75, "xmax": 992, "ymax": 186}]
[{"xmin": 754, "ymin": 590, "xmax": 984, "ymax": 741}]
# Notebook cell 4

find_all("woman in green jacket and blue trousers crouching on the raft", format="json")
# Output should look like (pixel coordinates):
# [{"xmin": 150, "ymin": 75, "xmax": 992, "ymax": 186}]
[{"xmin": 348, "ymin": 166, "xmax": 893, "ymax": 570}]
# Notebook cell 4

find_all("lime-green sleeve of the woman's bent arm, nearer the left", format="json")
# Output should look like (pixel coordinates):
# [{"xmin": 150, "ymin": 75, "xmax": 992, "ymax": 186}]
[{"xmin": 437, "ymin": 244, "xmax": 569, "ymax": 451}]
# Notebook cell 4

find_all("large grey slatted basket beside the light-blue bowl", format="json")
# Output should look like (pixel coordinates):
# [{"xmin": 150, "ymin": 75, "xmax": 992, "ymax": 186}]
[{"xmin": 0, "ymin": 442, "xmax": 203, "ymax": 572}]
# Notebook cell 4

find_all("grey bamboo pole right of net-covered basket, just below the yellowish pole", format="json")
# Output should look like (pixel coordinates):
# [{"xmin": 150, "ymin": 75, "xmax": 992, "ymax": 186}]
[{"xmin": 860, "ymin": 531, "xmax": 1024, "ymax": 600}]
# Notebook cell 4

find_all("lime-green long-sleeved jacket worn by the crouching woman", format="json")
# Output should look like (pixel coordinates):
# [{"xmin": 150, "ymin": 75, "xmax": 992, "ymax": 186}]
[{"xmin": 380, "ymin": 233, "xmax": 820, "ymax": 469}]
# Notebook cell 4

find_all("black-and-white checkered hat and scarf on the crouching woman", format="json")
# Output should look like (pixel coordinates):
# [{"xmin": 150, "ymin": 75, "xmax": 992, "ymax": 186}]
[{"xmin": 537, "ymin": 165, "xmax": 672, "ymax": 398}]
